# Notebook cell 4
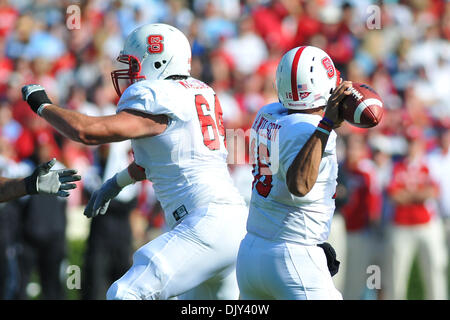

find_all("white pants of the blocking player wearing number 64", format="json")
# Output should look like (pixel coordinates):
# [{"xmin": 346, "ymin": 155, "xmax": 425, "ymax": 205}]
[{"xmin": 107, "ymin": 204, "xmax": 248, "ymax": 300}]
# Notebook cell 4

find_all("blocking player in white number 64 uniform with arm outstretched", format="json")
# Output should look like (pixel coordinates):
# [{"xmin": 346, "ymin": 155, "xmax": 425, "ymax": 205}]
[{"xmin": 23, "ymin": 24, "xmax": 248, "ymax": 299}]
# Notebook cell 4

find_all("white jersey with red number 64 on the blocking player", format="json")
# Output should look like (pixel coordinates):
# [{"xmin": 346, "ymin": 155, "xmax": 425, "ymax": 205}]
[{"xmin": 117, "ymin": 78, "xmax": 244, "ymax": 227}]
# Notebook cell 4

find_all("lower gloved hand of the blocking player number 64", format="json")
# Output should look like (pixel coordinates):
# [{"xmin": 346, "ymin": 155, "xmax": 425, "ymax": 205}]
[{"xmin": 84, "ymin": 176, "xmax": 122, "ymax": 218}]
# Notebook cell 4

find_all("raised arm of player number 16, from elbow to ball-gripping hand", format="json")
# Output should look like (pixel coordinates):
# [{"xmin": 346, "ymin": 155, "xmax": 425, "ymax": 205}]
[{"xmin": 286, "ymin": 81, "xmax": 352, "ymax": 197}]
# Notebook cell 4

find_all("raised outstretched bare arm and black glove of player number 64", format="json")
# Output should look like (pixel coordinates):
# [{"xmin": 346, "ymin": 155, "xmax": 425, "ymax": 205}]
[{"xmin": 22, "ymin": 85, "xmax": 168, "ymax": 145}]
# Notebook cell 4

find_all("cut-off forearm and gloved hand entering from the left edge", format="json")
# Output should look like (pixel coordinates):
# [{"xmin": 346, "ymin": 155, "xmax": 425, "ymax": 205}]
[{"xmin": 0, "ymin": 159, "xmax": 81, "ymax": 202}]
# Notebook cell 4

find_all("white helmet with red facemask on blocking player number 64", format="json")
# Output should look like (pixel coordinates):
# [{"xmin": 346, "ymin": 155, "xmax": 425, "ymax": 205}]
[{"xmin": 111, "ymin": 23, "xmax": 191, "ymax": 96}]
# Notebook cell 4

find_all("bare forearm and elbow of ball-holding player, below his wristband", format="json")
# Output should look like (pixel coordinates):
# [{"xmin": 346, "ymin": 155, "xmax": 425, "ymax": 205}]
[{"xmin": 286, "ymin": 130, "xmax": 328, "ymax": 197}]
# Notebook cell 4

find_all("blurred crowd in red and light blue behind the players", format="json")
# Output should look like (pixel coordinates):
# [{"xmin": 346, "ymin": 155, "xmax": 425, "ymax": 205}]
[{"xmin": 0, "ymin": 0, "xmax": 450, "ymax": 299}]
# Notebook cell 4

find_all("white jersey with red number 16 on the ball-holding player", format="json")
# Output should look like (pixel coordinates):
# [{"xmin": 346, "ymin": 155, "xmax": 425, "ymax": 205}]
[{"xmin": 247, "ymin": 103, "xmax": 338, "ymax": 245}]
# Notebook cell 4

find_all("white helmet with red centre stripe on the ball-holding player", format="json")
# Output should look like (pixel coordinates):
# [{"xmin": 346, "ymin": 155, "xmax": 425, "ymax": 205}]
[{"xmin": 276, "ymin": 46, "xmax": 340, "ymax": 110}]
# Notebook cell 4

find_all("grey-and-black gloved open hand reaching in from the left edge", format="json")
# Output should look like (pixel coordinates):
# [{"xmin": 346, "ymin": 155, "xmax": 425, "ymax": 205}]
[{"xmin": 25, "ymin": 159, "xmax": 81, "ymax": 197}]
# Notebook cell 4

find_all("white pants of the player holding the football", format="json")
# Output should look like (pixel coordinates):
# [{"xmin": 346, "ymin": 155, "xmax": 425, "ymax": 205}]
[{"xmin": 236, "ymin": 233, "xmax": 342, "ymax": 300}]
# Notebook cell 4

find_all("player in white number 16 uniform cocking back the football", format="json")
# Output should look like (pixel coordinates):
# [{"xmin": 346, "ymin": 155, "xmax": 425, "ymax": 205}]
[{"xmin": 237, "ymin": 46, "xmax": 351, "ymax": 300}]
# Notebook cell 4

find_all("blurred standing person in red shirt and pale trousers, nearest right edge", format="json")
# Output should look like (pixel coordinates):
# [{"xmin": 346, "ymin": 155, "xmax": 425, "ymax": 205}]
[{"xmin": 383, "ymin": 127, "xmax": 447, "ymax": 299}]
